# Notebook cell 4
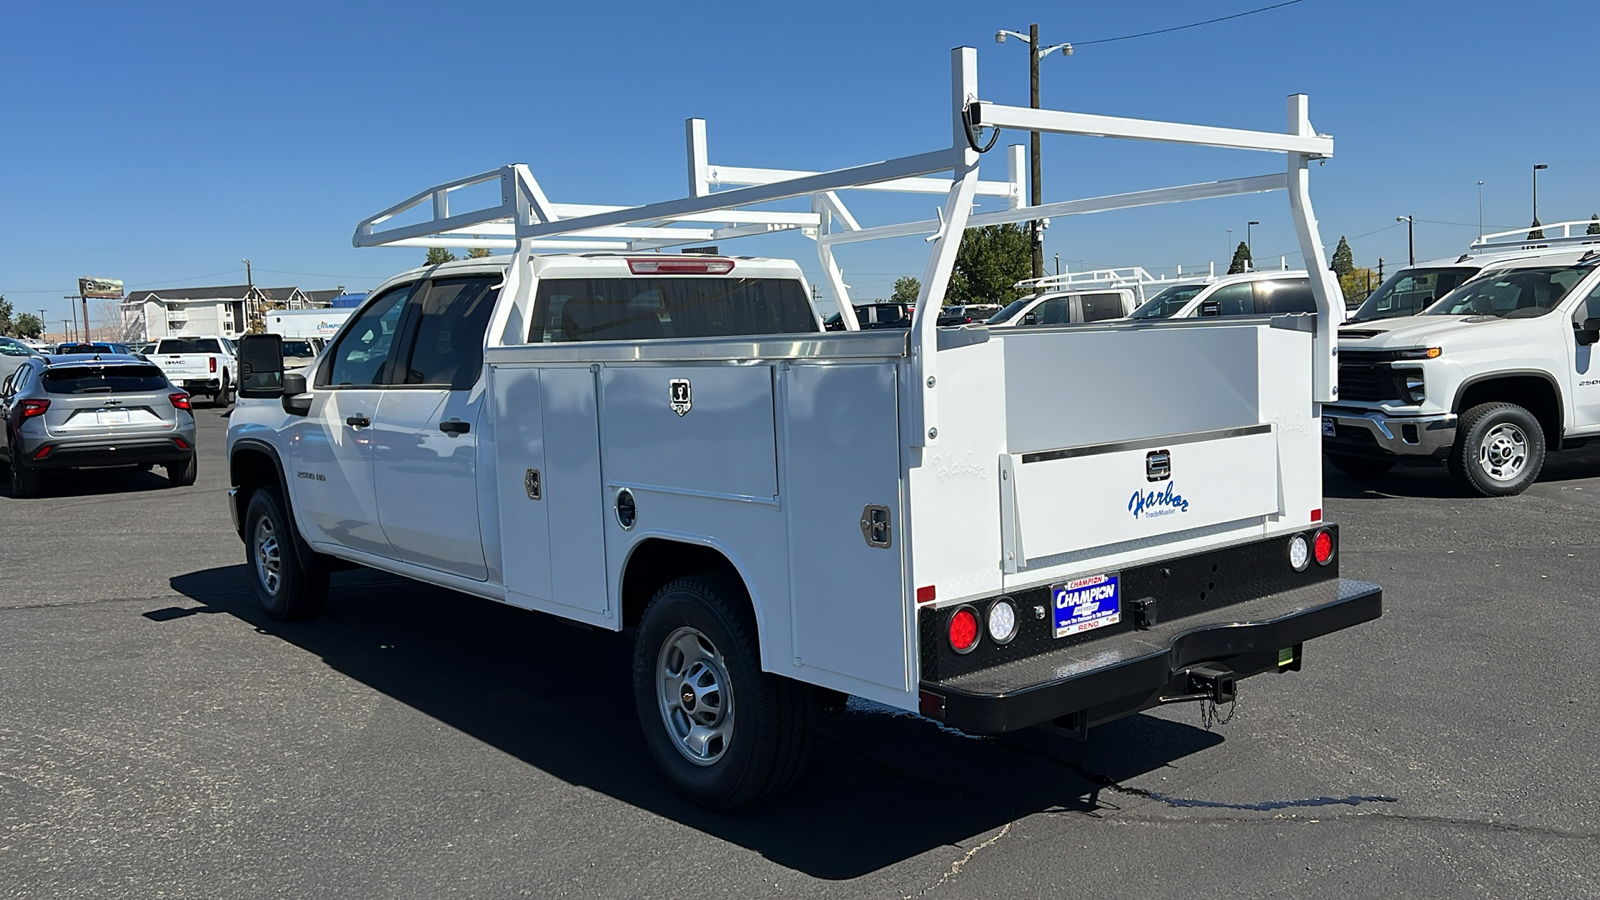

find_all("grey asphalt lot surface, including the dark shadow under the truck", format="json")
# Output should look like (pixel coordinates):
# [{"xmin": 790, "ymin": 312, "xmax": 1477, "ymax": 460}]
[{"xmin": 0, "ymin": 410, "xmax": 1600, "ymax": 900}]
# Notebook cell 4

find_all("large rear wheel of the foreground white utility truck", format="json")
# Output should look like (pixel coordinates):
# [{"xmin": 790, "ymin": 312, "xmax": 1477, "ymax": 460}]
[{"xmin": 634, "ymin": 575, "xmax": 811, "ymax": 812}]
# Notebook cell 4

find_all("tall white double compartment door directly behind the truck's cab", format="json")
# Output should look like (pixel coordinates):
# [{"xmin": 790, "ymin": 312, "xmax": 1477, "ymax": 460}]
[{"xmin": 493, "ymin": 367, "xmax": 616, "ymax": 628}]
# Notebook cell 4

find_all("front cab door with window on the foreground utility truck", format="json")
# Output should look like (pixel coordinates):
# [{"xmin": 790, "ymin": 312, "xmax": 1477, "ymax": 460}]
[{"xmin": 288, "ymin": 283, "xmax": 416, "ymax": 557}]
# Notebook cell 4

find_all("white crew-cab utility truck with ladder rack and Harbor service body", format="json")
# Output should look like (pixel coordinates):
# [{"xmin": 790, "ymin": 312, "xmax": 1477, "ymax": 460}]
[{"xmin": 227, "ymin": 48, "xmax": 1382, "ymax": 809}]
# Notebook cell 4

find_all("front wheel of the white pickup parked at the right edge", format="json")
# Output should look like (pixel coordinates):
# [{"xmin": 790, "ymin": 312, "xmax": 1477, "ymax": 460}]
[{"xmin": 1450, "ymin": 404, "xmax": 1546, "ymax": 496}]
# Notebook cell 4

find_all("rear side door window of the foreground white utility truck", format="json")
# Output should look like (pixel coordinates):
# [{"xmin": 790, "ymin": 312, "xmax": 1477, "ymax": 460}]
[{"xmin": 394, "ymin": 279, "xmax": 499, "ymax": 391}]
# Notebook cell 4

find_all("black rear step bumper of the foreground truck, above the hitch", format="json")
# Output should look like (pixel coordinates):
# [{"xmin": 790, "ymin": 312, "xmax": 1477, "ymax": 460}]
[{"xmin": 922, "ymin": 578, "xmax": 1384, "ymax": 733}]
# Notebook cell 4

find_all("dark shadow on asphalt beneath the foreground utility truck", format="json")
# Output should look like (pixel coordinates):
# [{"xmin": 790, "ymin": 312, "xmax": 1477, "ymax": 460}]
[{"xmin": 168, "ymin": 565, "xmax": 1222, "ymax": 879}]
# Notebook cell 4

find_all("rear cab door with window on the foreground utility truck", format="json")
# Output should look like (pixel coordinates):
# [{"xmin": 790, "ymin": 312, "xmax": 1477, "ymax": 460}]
[{"xmin": 371, "ymin": 275, "xmax": 499, "ymax": 581}]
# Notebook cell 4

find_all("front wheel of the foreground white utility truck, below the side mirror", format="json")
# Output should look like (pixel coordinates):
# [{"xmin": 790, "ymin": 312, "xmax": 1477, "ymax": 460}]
[{"xmin": 245, "ymin": 485, "xmax": 330, "ymax": 621}]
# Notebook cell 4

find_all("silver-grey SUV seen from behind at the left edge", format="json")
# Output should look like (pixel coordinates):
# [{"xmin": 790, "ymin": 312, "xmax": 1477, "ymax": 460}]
[{"xmin": 0, "ymin": 356, "xmax": 195, "ymax": 496}]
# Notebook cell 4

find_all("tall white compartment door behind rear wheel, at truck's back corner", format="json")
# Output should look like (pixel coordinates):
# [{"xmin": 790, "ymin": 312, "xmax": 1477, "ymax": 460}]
[{"xmin": 771, "ymin": 364, "xmax": 912, "ymax": 703}]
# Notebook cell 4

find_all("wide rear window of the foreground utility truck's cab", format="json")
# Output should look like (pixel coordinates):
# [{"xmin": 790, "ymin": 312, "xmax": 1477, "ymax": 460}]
[{"xmin": 528, "ymin": 277, "xmax": 819, "ymax": 343}]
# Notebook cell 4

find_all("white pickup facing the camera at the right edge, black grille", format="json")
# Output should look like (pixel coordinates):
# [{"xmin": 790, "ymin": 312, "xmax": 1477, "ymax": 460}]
[{"xmin": 1322, "ymin": 223, "xmax": 1600, "ymax": 496}]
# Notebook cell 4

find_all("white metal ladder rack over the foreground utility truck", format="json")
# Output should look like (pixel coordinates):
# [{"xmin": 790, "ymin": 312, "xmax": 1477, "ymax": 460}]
[{"xmin": 354, "ymin": 46, "xmax": 1342, "ymax": 447}]
